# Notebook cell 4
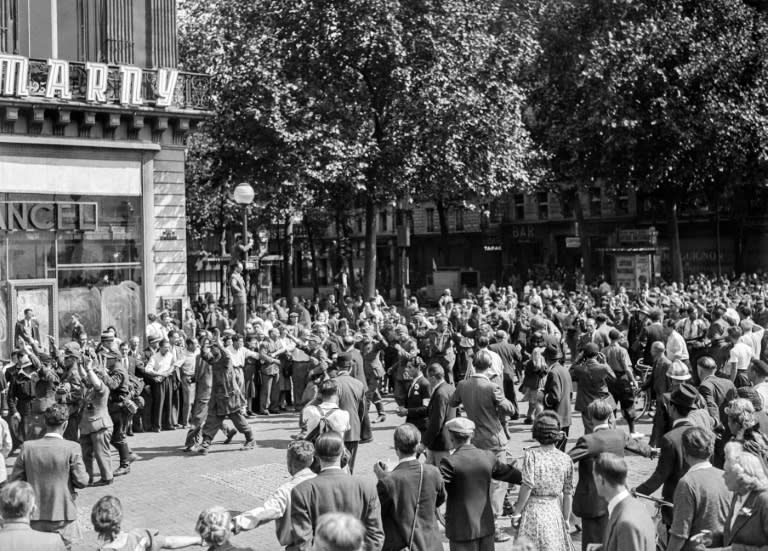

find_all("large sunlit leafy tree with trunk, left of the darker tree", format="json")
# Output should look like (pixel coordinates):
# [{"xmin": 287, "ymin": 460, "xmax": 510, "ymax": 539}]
[{"xmin": 183, "ymin": 0, "xmax": 544, "ymax": 296}]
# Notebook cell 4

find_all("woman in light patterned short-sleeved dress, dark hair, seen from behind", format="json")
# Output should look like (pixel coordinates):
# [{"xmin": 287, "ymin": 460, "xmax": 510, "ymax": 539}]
[{"xmin": 514, "ymin": 411, "xmax": 573, "ymax": 551}]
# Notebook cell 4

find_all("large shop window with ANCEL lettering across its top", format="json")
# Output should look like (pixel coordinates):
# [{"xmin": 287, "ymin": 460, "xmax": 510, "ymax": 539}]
[{"xmin": 0, "ymin": 193, "xmax": 144, "ymax": 357}]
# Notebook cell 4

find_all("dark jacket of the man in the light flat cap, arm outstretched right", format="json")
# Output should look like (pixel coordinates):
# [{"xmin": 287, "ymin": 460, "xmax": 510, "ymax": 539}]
[{"xmin": 440, "ymin": 444, "xmax": 523, "ymax": 541}]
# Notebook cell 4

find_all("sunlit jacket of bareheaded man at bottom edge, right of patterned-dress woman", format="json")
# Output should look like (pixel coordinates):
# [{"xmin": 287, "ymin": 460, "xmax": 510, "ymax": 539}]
[{"xmin": 602, "ymin": 496, "xmax": 656, "ymax": 551}]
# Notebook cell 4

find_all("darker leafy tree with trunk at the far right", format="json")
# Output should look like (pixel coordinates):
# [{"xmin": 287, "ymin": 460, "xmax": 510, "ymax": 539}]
[{"xmin": 531, "ymin": 0, "xmax": 768, "ymax": 281}]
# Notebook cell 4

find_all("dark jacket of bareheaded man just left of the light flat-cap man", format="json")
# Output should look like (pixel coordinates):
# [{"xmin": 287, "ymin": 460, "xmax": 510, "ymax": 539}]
[{"xmin": 377, "ymin": 461, "xmax": 445, "ymax": 551}]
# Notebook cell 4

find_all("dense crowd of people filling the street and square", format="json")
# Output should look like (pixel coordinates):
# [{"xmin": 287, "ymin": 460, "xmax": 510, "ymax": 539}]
[{"xmin": 0, "ymin": 265, "xmax": 768, "ymax": 551}]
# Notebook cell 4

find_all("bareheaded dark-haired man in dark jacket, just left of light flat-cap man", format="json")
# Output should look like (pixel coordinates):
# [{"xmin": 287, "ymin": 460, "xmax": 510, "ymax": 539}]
[{"xmin": 373, "ymin": 422, "xmax": 445, "ymax": 551}]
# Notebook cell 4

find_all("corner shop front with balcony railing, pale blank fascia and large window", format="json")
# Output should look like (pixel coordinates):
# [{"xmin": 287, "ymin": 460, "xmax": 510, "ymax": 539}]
[{"xmin": 0, "ymin": 55, "xmax": 208, "ymax": 359}]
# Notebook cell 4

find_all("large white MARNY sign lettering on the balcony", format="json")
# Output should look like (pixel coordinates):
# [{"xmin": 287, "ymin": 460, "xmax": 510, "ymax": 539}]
[{"xmin": 0, "ymin": 55, "xmax": 179, "ymax": 107}]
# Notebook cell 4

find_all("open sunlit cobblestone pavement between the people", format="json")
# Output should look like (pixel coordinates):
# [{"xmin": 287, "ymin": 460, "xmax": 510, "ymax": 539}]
[{"xmin": 4, "ymin": 401, "xmax": 655, "ymax": 551}]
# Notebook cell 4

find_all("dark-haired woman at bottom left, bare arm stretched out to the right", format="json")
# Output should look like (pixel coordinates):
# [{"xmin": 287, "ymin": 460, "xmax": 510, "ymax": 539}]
[{"xmin": 91, "ymin": 496, "xmax": 203, "ymax": 551}]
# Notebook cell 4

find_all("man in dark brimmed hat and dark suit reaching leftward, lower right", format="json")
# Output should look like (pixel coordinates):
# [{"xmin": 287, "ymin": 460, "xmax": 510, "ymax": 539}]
[{"xmin": 635, "ymin": 383, "xmax": 698, "ymax": 527}]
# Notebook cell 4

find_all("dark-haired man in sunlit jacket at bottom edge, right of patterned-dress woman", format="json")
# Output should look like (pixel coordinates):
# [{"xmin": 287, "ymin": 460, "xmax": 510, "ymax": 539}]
[{"xmin": 593, "ymin": 452, "xmax": 656, "ymax": 551}]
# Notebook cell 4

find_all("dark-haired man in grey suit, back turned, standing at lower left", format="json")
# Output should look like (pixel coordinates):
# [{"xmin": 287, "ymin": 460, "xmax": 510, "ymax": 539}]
[{"xmin": 10, "ymin": 404, "xmax": 89, "ymax": 549}]
